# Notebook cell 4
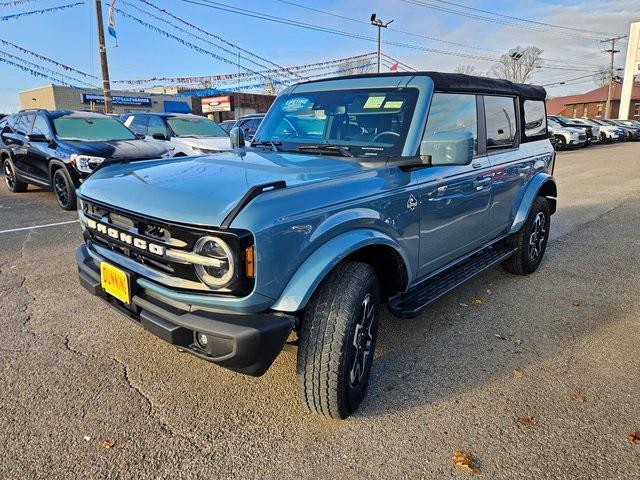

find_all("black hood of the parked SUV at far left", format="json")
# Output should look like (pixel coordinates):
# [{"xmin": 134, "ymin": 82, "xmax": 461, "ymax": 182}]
[{"xmin": 59, "ymin": 140, "xmax": 167, "ymax": 161}]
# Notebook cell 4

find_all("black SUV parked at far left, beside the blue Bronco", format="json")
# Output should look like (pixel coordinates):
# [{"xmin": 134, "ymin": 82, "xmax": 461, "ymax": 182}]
[{"xmin": 0, "ymin": 110, "xmax": 168, "ymax": 210}]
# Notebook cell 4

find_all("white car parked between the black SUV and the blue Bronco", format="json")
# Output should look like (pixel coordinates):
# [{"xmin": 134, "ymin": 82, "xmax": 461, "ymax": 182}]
[{"xmin": 120, "ymin": 112, "xmax": 231, "ymax": 157}]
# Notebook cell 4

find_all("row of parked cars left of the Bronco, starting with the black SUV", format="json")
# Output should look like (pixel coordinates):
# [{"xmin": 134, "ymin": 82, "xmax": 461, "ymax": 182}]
[{"xmin": 0, "ymin": 110, "xmax": 263, "ymax": 210}]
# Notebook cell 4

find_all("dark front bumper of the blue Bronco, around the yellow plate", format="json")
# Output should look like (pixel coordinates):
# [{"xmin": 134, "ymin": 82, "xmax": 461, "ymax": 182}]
[{"xmin": 76, "ymin": 245, "xmax": 295, "ymax": 376}]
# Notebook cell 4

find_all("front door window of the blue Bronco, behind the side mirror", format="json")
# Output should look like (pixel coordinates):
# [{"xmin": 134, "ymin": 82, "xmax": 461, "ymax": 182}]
[{"xmin": 423, "ymin": 93, "xmax": 478, "ymax": 153}]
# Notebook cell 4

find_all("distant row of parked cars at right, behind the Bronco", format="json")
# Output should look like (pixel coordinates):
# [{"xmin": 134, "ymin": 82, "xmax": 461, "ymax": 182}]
[{"xmin": 547, "ymin": 115, "xmax": 640, "ymax": 150}]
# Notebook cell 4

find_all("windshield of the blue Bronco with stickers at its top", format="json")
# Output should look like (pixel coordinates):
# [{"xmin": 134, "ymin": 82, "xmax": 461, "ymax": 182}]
[{"xmin": 253, "ymin": 88, "xmax": 418, "ymax": 157}]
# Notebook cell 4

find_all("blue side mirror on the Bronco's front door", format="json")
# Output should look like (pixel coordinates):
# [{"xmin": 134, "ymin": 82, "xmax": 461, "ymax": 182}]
[{"xmin": 420, "ymin": 130, "xmax": 474, "ymax": 166}]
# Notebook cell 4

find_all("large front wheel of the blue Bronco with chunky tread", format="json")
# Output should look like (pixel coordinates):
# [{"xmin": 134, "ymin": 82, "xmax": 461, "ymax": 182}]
[{"xmin": 297, "ymin": 261, "xmax": 380, "ymax": 419}]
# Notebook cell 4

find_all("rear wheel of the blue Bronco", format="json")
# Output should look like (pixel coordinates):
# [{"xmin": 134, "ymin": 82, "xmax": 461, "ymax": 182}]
[{"xmin": 504, "ymin": 197, "xmax": 551, "ymax": 275}]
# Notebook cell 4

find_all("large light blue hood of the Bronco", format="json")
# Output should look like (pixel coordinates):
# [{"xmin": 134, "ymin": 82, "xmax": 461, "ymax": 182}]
[{"xmin": 80, "ymin": 151, "xmax": 372, "ymax": 226}]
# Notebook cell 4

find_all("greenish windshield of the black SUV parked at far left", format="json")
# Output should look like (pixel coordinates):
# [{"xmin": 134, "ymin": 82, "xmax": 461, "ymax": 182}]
[{"xmin": 53, "ymin": 117, "xmax": 136, "ymax": 142}]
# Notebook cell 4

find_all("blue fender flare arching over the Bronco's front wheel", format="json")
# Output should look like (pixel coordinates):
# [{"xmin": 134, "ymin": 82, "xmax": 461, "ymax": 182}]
[{"xmin": 271, "ymin": 229, "xmax": 411, "ymax": 312}]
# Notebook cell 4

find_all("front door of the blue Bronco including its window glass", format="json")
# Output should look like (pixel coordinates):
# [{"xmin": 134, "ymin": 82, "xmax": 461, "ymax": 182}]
[{"xmin": 414, "ymin": 93, "xmax": 491, "ymax": 277}]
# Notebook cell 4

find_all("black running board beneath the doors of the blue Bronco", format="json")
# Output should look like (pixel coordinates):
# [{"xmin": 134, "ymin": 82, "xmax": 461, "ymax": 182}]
[{"xmin": 389, "ymin": 245, "xmax": 515, "ymax": 318}]
